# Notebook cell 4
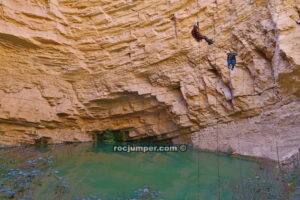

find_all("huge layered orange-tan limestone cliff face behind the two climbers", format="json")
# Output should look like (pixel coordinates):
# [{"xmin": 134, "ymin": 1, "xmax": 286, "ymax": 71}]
[{"xmin": 0, "ymin": 0, "xmax": 300, "ymax": 159}]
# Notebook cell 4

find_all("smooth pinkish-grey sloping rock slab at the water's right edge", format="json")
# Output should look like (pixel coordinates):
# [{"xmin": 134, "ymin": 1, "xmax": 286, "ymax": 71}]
[{"xmin": 192, "ymin": 102, "xmax": 300, "ymax": 160}]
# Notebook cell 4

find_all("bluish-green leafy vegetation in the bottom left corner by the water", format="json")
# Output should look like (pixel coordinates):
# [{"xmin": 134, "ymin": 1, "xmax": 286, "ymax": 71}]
[{"xmin": 0, "ymin": 151, "xmax": 69, "ymax": 200}]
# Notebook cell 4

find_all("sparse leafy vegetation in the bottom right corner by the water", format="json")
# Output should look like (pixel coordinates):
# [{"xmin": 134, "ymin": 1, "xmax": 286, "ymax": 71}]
[{"xmin": 234, "ymin": 157, "xmax": 300, "ymax": 200}]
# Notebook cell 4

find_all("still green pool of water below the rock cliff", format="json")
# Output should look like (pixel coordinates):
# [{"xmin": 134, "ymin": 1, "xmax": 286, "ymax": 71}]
[{"xmin": 0, "ymin": 143, "xmax": 272, "ymax": 200}]
